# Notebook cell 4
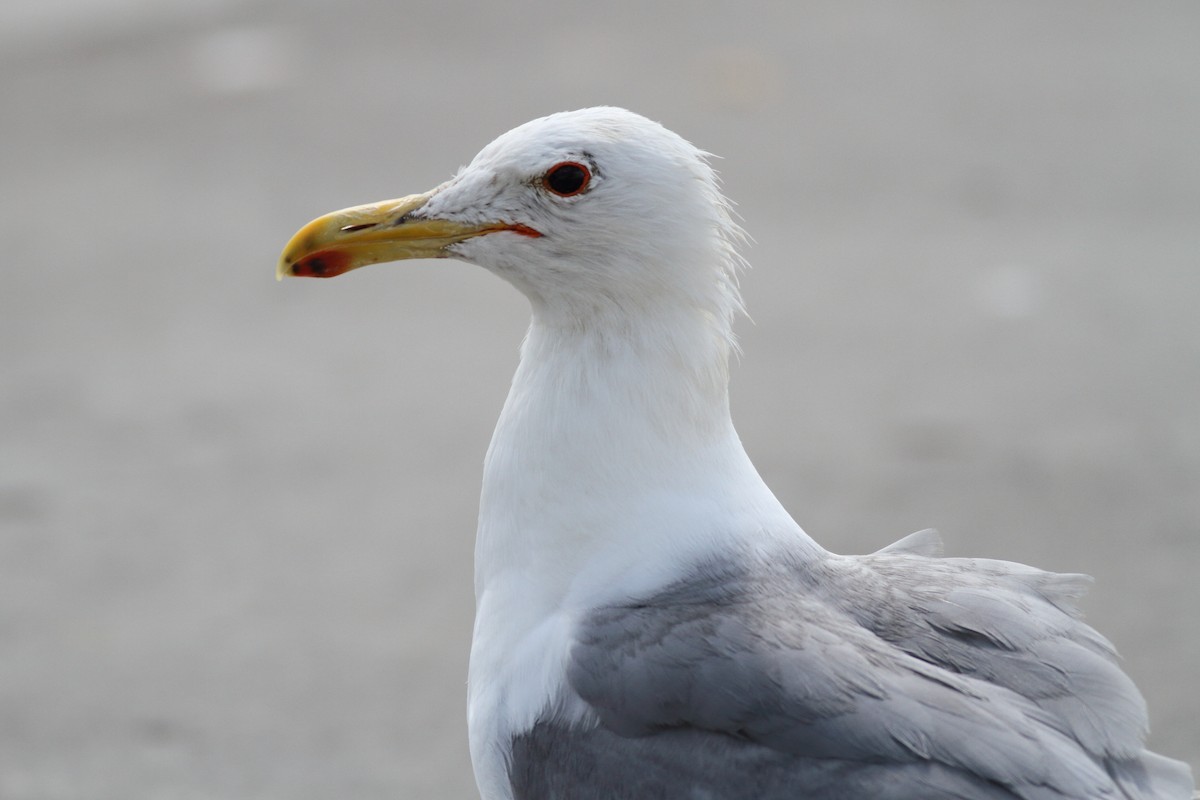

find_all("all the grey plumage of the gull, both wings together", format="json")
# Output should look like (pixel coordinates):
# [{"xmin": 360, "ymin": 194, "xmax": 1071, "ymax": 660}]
[{"xmin": 512, "ymin": 544, "xmax": 1192, "ymax": 800}]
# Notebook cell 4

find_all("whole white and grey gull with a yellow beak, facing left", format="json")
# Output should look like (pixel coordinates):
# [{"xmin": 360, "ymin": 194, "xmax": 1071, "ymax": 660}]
[{"xmin": 277, "ymin": 108, "xmax": 1194, "ymax": 800}]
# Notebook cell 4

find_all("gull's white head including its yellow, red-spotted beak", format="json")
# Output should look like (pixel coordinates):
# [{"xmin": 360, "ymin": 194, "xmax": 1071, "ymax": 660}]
[{"xmin": 280, "ymin": 108, "xmax": 740, "ymax": 335}]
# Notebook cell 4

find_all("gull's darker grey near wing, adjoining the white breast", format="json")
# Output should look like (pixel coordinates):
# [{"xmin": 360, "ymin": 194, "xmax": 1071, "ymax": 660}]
[{"xmin": 512, "ymin": 553, "xmax": 1188, "ymax": 800}]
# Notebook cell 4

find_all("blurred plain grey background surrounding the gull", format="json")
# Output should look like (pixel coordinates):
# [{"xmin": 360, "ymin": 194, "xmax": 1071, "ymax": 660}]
[{"xmin": 0, "ymin": 0, "xmax": 1200, "ymax": 800}]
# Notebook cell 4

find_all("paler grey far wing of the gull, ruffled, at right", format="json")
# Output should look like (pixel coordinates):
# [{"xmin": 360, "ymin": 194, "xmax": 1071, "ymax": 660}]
[{"xmin": 822, "ymin": 531, "xmax": 1193, "ymax": 798}]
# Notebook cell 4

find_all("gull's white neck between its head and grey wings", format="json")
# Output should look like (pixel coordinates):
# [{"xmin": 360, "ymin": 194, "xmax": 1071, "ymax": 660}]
[{"xmin": 475, "ymin": 307, "xmax": 817, "ymax": 610}]
